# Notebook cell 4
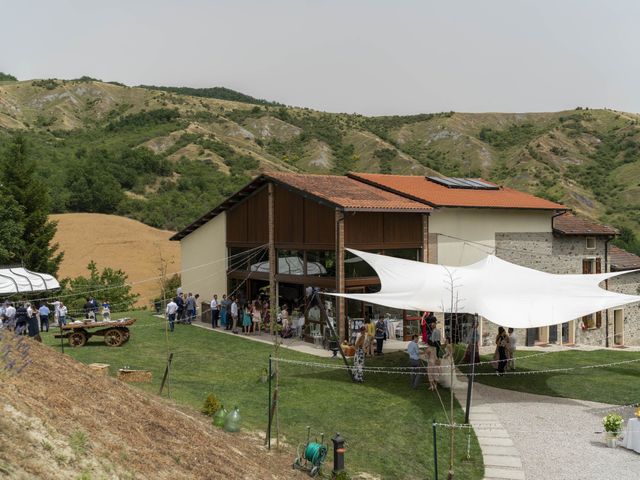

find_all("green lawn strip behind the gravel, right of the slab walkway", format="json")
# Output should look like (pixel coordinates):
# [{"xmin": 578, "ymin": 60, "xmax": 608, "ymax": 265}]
[{"xmin": 460, "ymin": 350, "xmax": 640, "ymax": 405}]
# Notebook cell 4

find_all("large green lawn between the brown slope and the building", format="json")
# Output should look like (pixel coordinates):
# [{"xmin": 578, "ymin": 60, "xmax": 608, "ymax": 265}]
[{"xmin": 44, "ymin": 312, "xmax": 483, "ymax": 480}]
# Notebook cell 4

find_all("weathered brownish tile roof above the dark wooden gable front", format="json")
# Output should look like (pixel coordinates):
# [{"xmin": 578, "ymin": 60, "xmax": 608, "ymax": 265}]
[{"xmin": 263, "ymin": 172, "xmax": 433, "ymax": 212}]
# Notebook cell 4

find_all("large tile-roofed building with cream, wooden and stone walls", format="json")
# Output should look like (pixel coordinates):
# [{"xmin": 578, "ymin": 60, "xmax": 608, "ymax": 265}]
[{"xmin": 172, "ymin": 173, "xmax": 632, "ymax": 344}]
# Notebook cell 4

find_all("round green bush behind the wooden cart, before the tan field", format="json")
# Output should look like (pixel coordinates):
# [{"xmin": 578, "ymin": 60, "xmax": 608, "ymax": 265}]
[{"xmin": 63, "ymin": 260, "xmax": 139, "ymax": 311}]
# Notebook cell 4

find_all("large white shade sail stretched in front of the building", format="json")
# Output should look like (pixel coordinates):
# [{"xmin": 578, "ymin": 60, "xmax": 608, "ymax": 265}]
[{"xmin": 330, "ymin": 249, "xmax": 640, "ymax": 328}]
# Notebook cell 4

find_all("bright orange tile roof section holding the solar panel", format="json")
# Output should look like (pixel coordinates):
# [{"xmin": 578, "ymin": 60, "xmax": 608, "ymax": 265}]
[{"xmin": 349, "ymin": 173, "xmax": 567, "ymax": 210}]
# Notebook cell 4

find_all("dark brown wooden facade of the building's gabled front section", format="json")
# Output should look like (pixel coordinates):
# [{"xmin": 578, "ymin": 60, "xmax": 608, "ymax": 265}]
[{"xmin": 226, "ymin": 182, "xmax": 428, "ymax": 338}]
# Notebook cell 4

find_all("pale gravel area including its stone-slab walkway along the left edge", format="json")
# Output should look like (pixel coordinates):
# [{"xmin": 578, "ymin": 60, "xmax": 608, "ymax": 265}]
[{"xmin": 454, "ymin": 376, "xmax": 640, "ymax": 480}]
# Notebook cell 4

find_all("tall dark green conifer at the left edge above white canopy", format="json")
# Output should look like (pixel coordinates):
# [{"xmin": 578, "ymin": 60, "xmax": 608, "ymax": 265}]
[{"xmin": 0, "ymin": 135, "xmax": 63, "ymax": 275}]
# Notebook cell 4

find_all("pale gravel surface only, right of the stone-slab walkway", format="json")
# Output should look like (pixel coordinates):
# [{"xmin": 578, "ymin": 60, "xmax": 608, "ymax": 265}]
[{"xmin": 472, "ymin": 383, "xmax": 640, "ymax": 480}]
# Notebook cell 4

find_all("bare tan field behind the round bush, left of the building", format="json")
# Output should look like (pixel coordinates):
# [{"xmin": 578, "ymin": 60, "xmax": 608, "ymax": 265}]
[{"xmin": 51, "ymin": 213, "xmax": 180, "ymax": 305}]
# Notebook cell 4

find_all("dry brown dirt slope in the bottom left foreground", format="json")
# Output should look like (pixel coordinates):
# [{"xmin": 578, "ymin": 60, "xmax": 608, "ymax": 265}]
[{"xmin": 0, "ymin": 340, "xmax": 301, "ymax": 480}]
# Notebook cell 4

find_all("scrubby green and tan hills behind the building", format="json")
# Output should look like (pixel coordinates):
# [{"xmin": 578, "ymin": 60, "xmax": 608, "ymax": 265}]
[{"xmin": 0, "ymin": 78, "xmax": 640, "ymax": 246}]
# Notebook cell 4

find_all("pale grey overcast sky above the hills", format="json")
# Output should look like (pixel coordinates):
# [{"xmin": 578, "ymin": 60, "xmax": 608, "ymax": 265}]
[{"xmin": 0, "ymin": 0, "xmax": 640, "ymax": 115}]
